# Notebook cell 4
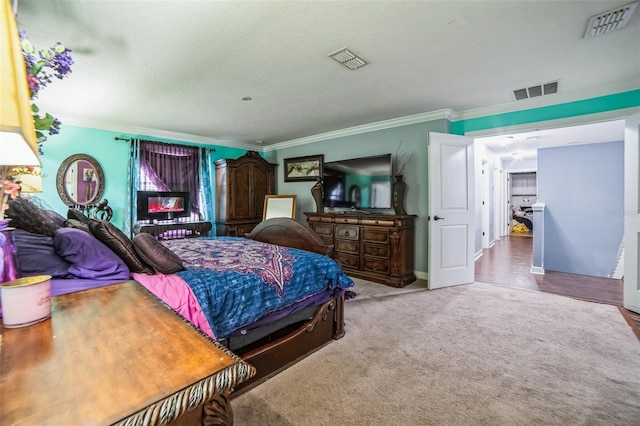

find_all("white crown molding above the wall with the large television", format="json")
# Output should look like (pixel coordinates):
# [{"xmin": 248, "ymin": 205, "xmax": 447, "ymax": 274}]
[{"xmin": 264, "ymin": 109, "xmax": 455, "ymax": 151}]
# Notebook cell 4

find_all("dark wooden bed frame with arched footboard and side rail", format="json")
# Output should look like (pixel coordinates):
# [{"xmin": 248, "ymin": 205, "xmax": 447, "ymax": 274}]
[{"xmin": 231, "ymin": 218, "xmax": 344, "ymax": 397}]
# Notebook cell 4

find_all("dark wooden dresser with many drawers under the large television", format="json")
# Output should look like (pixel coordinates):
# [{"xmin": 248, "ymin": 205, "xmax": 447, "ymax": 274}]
[{"xmin": 305, "ymin": 213, "xmax": 416, "ymax": 287}]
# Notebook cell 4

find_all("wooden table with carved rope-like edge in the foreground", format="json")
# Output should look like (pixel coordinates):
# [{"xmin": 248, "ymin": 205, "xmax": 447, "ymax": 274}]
[{"xmin": 0, "ymin": 281, "xmax": 255, "ymax": 426}]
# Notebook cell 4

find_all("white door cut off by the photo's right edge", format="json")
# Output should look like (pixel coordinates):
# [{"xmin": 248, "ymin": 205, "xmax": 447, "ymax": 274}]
[{"xmin": 623, "ymin": 114, "xmax": 640, "ymax": 313}]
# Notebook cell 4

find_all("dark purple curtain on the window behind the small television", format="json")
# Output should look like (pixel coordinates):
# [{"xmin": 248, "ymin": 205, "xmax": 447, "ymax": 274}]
[{"xmin": 140, "ymin": 141, "xmax": 200, "ymax": 213}]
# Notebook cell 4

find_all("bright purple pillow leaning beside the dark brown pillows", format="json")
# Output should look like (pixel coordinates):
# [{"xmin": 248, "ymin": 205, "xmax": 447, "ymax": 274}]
[{"xmin": 53, "ymin": 228, "xmax": 130, "ymax": 281}]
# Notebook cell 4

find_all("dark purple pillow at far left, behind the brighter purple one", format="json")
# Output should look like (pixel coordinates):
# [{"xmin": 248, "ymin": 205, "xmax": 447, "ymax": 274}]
[{"xmin": 11, "ymin": 229, "xmax": 73, "ymax": 278}]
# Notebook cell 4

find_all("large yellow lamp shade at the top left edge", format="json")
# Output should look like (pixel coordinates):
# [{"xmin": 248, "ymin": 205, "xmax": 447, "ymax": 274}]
[{"xmin": 0, "ymin": 0, "xmax": 40, "ymax": 166}]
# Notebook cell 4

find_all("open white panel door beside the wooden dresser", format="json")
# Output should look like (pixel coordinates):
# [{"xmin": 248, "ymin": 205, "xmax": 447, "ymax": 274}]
[{"xmin": 428, "ymin": 132, "xmax": 475, "ymax": 289}]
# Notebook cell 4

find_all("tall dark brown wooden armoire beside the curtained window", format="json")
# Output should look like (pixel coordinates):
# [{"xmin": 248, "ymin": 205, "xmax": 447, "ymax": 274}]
[{"xmin": 215, "ymin": 151, "xmax": 276, "ymax": 237}]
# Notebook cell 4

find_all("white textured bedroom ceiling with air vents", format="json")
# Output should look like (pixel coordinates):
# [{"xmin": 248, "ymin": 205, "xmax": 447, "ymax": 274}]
[{"xmin": 13, "ymin": 0, "xmax": 640, "ymax": 150}]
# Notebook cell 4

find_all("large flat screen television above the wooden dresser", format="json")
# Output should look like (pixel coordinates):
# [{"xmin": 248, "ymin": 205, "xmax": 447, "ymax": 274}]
[{"xmin": 322, "ymin": 154, "xmax": 392, "ymax": 210}]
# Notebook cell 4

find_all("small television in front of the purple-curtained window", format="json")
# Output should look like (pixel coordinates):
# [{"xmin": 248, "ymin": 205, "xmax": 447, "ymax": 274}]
[{"xmin": 136, "ymin": 191, "xmax": 191, "ymax": 220}]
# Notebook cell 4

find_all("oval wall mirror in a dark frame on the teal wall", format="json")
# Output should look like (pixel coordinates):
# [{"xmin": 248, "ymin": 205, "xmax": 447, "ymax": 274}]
[{"xmin": 56, "ymin": 154, "xmax": 104, "ymax": 206}]
